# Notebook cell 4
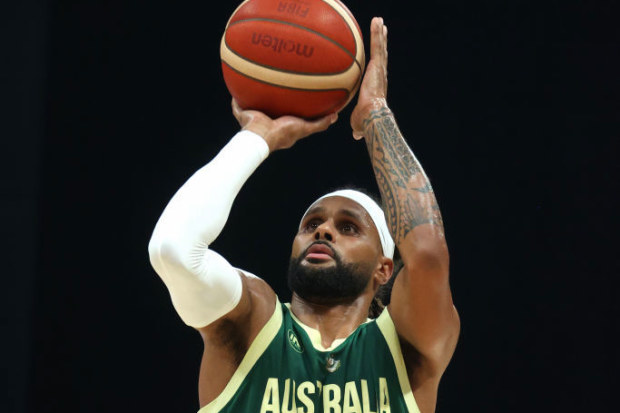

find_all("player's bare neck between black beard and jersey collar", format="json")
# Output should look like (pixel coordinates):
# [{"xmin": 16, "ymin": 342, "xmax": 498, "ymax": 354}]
[{"xmin": 291, "ymin": 293, "xmax": 372, "ymax": 348}]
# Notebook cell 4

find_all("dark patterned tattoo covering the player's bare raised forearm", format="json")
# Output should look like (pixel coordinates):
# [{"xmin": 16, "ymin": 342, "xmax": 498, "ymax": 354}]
[{"xmin": 364, "ymin": 108, "xmax": 443, "ymax": 245}]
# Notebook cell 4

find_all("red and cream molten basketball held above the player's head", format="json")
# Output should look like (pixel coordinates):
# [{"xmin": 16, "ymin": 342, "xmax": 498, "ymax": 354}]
[{"xmin": 220, "ymin": 0, "xmax": 365, "ymax": 119}]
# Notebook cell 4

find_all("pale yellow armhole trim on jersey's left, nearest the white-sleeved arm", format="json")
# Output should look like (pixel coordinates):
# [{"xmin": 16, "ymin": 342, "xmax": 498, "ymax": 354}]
[{"xmin": 198, "ymin": 297, "xmax": 282, "ymax": 413}]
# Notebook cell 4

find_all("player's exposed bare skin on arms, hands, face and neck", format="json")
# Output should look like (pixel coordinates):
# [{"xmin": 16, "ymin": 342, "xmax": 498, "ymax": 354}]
[{"xmin": 199, "ymin": 18, "xmax": 460, "ymax": 413}]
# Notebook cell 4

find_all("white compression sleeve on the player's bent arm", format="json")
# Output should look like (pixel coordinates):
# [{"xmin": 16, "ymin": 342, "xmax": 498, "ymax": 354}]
[{"xmin": 149, "ymin": 131, "xmax": 269, "ymax": 328}]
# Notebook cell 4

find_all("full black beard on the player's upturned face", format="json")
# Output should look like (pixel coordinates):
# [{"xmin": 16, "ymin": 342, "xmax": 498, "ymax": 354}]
[{"xmin": 288, "ymin": 241, "xmax": 373, "ymax": 304}]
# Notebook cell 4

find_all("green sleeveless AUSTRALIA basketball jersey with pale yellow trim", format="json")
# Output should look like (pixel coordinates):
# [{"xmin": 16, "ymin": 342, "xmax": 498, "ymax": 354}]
[{"xmin": 199, "ymin": 301, "xmax": 420, "ymax": 413}]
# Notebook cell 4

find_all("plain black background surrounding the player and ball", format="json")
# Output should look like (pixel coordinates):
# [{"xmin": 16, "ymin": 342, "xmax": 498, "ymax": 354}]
[{"xmin": 6, "ymin": 0, "xmax": 620, "ymax": 413}]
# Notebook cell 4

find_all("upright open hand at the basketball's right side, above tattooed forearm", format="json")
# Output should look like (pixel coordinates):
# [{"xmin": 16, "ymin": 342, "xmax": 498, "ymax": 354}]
[{"xmin": 351, "ymin": 17, "xmax": 388, "ymax": 139}]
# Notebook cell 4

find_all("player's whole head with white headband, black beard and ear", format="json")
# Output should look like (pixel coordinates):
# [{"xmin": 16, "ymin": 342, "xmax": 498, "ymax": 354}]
[{"xmin": 288, "ymin": 189, "xmax": 394, "ymax": 303}]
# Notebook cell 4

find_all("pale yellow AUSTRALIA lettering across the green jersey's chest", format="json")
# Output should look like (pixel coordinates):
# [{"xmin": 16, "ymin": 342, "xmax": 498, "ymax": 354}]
[{"xmin": 260, "ymin": 377, "xmax": 391, "ymax": 413}]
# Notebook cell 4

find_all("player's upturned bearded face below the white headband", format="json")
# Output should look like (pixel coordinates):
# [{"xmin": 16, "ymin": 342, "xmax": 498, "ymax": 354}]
[{"xmin": 288, "ymin": 197, "xmax": 382, "ymax": 301}]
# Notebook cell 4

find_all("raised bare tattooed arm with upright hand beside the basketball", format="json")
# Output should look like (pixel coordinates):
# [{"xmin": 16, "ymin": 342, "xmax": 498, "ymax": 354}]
[{"xmin": 351, "ymin": 19, "xmax": 459, "ymax": 388}]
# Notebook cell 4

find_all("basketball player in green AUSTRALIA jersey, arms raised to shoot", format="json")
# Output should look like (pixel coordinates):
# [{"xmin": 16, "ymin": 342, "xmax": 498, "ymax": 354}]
[{"xmin": 149, "ymin": 18, "xmax": 459, "ymax": 413}]
